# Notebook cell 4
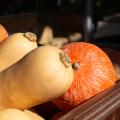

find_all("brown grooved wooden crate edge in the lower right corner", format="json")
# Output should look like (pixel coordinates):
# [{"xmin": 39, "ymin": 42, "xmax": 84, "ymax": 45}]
[{"xmin": 59, "ymin": 82, "xmax": 120, "ymax": 120}]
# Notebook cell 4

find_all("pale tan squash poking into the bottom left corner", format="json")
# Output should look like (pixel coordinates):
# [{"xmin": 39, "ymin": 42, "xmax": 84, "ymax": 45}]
[{"xmin": 0, "ymin": 108, "xmax": 33, "ymax": 120}]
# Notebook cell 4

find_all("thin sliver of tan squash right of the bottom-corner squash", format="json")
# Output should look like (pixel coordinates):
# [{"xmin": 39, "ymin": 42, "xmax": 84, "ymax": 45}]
[{"xmin": 24, "ymin": 110, "xmax": 45, "ymax": 120}]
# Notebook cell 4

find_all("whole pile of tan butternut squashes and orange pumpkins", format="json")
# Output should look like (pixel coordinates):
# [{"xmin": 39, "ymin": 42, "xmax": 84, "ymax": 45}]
[{"xmin": 0, "ymin": 25, "xmax": 117, "ymax": 120}]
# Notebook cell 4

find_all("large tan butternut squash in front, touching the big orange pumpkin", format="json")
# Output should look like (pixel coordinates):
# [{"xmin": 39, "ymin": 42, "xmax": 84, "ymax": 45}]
[{"xmin": 0, "ymin": 46, "xmax": 73, "ymax": 109}]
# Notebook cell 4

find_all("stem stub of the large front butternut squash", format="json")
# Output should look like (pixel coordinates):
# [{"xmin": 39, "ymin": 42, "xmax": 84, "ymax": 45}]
[{"xmin": 59, "ymin": 53, "xmax": 71, "ymax": 68}]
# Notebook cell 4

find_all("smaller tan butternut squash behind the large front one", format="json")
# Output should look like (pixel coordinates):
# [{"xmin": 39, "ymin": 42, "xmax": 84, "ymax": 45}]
[{"xmin": 0, "ymin": 32, "xmax": 37, "ymax": 71}]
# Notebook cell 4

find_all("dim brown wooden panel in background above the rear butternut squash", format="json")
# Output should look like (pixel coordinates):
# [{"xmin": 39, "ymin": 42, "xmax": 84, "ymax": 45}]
[{"xmin": 0, "ymin": 13, "xmax": 38, "ymax": 32}]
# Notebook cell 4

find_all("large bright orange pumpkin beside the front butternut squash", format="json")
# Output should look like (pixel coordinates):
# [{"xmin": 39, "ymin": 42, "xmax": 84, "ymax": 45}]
[{"xmin": 53, "ymin": 42, "xmax": 116, "ymax": 110}]
